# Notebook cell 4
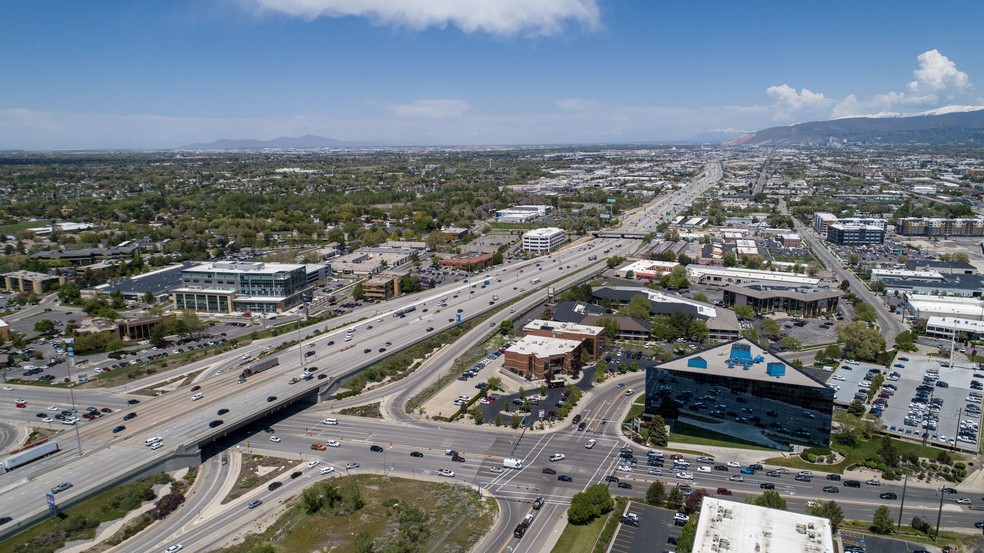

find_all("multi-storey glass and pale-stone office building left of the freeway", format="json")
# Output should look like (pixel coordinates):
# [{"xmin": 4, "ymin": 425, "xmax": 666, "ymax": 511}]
[{"xmin": 172, "ymin": 261, "xmax": 307, "ymax": 313}]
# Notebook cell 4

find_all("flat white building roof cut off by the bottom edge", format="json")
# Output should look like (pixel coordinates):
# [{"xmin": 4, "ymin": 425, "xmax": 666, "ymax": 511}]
[{"xmin": 691, "ymin": 496, "xmax": 834, "ymax": 553}]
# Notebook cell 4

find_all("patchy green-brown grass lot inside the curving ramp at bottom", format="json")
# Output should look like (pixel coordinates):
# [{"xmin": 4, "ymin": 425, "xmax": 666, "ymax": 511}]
[{"xmin": 213, "ymin": 475, "xmax": 497, "ymax": 553}]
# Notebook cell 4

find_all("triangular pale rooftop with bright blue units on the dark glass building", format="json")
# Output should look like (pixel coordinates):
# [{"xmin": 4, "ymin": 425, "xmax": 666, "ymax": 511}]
[{"xmin": 658, "ymin": 338, "xmax": 826, "ymax": 388}]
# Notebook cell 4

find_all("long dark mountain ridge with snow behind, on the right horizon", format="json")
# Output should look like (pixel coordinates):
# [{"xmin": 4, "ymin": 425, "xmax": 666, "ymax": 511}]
[{"xmin": 728, "ymin": 106, "xmax": 984, "ymax": 146}]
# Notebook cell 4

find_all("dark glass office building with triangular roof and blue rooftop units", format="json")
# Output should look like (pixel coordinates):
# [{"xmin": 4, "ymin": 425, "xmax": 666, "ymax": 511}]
[{"xmin": 645, "ymin": 338, "xmax": 834, "ymax": 450}]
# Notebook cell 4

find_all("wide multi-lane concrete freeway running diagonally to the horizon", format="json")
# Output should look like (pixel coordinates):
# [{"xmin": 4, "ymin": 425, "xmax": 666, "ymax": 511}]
[{"xmin": 0, "ymin": 162, "xmax": 720, "ymax": 544}]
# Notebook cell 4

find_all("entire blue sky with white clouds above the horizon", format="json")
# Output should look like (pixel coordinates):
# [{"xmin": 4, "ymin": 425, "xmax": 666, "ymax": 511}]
[{"xmin": 0, "ymin": 0, "xmax": 984, "ymax": 149}]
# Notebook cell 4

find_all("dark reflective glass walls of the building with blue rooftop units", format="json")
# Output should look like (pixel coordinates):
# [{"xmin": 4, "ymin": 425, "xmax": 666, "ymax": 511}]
[{"xmin": 645, "ymin": 367, "xmax": 834, "ymax": 449}]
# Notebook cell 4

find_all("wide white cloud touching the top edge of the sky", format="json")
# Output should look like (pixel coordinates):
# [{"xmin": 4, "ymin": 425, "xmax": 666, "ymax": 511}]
[{"xmin": 239, "ymin": 0, "xmax": 600, "ymax": 35}]
